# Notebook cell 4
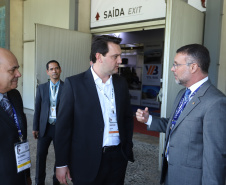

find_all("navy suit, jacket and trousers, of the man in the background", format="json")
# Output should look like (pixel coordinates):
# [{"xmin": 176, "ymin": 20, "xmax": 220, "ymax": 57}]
[{"xmin": 33, "ymin": 81, "xmax": 64, "ymax": 184}]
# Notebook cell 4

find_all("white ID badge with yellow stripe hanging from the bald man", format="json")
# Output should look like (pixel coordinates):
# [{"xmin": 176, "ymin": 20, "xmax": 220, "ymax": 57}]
[{"xmin": 14, "ymin": 141, "xmax": 31, "ymax": 173}]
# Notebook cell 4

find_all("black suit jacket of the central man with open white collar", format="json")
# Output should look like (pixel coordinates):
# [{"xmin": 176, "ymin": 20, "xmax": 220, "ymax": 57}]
[{"xmin": 55, "ymin": 69, "xmax": 134, "ymax": 182}]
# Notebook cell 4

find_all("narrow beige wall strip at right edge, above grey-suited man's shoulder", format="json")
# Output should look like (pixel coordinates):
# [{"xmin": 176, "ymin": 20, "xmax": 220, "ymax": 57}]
[{"xmin": 217, "ymin": 1, "xmax": 226, "ymax": 94}]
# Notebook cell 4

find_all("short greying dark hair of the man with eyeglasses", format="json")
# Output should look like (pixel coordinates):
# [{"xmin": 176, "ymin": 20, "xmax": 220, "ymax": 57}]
[{"xmin": 177, "ymin": 44, "xmax": 210, "ymax": 73}]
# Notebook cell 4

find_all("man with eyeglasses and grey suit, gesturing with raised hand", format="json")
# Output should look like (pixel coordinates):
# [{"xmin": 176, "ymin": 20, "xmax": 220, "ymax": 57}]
[{"xmin": 136, "ymin": 44, "xmax": 226, "ymax": 185}]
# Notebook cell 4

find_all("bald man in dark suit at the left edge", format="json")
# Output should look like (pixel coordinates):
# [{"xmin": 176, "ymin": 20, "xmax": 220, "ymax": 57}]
[{"xmin": 0, "ymin": 48, "xmax": 31, "ymax": 185}]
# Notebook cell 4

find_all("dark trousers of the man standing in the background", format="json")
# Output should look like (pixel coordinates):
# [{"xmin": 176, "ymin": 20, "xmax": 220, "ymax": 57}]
[{"xmin": 35, "ymin": 123, "xmax": 59, "ymax": 185}]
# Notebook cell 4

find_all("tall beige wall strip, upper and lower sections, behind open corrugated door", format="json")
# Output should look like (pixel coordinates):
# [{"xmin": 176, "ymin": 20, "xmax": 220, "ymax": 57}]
[{"xmin": 22, "ymin": 0, "xmax": 70, "ymax": 109}]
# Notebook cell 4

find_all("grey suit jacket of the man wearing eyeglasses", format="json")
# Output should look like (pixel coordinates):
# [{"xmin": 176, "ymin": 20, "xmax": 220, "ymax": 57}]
[{"xmin": 150, "ymin": 81, "xmax": 226, "ymax": 185}]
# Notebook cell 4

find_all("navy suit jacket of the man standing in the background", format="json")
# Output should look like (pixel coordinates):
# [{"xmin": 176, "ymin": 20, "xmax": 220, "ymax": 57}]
[{"xmin": 33, "ymin": 81, "xmax": 64, "ymax": 137}]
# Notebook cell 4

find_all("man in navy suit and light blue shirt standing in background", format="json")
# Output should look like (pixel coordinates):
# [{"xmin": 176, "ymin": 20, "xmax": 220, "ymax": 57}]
[{"xmin": 32, "ymin": 60, "xmax": 64, "ymax": 185}]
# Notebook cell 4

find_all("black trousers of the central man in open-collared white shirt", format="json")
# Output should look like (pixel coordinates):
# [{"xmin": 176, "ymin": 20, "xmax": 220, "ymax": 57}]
[{"xmin": 74, "ymin": 147, "xmax": 128, "ymax": 185}]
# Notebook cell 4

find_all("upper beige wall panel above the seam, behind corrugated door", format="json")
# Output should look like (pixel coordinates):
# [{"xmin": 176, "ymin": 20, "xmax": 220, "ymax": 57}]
[{"xmin": 24, "ymin": 0, "xmax": 70, "ymax": 41}]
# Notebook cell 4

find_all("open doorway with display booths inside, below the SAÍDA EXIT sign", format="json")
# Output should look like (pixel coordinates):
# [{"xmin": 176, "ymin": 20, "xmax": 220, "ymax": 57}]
[{"xmin": 111, "ymin": 28, "xmax": 164, "ymax": 137}]
